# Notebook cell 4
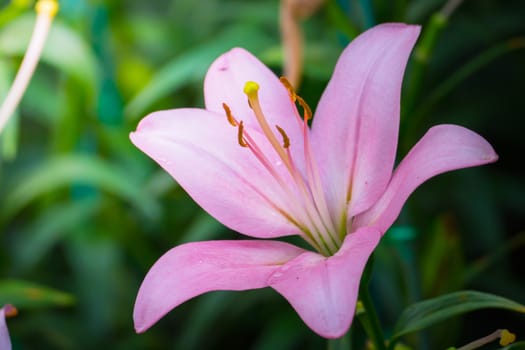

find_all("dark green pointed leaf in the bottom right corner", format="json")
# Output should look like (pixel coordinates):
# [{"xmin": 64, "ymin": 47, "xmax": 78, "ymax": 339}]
[{"xmin": 392, "ymin": 290, "xmax": 525, "ymax": 339}]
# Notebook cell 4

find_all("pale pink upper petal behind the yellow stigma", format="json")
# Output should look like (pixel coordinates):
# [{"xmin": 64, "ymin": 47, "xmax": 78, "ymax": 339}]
[{"xmin": 204, "ymin": 48, "xmax": 304, "ymax": 168}]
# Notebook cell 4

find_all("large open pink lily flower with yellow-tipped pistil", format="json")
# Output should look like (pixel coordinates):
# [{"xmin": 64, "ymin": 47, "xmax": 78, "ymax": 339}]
[{"xmin": 130, "ymin": 24, "xmax": 497, "ymax": 338}]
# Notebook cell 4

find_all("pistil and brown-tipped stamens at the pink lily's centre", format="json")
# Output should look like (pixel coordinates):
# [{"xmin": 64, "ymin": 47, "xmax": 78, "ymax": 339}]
[{"xmin": 223, "ymin": 78, "xmax": 346, "ymax": 256}]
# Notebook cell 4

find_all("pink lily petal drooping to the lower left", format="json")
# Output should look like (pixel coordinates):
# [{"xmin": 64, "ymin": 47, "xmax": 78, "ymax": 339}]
[{"xmin": 133, "ymin": 241, "xmax": 304, "ymax": 333}]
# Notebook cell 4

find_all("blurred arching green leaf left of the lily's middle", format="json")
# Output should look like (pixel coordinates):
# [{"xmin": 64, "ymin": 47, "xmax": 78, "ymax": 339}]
[{"xmin": 0, "ymin": 155, "xmax": 161, "ymax": 219}]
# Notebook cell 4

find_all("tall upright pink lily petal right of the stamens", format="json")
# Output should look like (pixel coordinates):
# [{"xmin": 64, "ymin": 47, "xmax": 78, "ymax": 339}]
[{"xmin": 312, "ymin": 24, "xmax": 420, "ymax": 221}]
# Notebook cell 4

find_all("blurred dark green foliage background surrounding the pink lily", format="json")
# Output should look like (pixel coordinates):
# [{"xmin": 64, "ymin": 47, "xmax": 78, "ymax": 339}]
[{"xmin": 0, "ymin": 0, "xmax": 525, "ymax": 350}]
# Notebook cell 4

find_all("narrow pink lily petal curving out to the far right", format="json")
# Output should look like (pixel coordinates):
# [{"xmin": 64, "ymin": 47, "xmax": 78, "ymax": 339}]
[{"xmin": 354, "ymin": 125, "xmax": 498, "ymax": 233}]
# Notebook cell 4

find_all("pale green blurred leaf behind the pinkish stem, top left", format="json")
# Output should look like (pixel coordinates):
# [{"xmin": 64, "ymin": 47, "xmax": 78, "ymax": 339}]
[{"xmin": 0, "ymin": 14, "xmax": 98, "ymax": 92}]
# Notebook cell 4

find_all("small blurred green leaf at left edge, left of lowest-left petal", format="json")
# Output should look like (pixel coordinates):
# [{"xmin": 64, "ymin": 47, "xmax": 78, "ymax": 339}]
[{"xmin": 0, "ymin": 280, "xmax": 75, "ymax": 309}]
